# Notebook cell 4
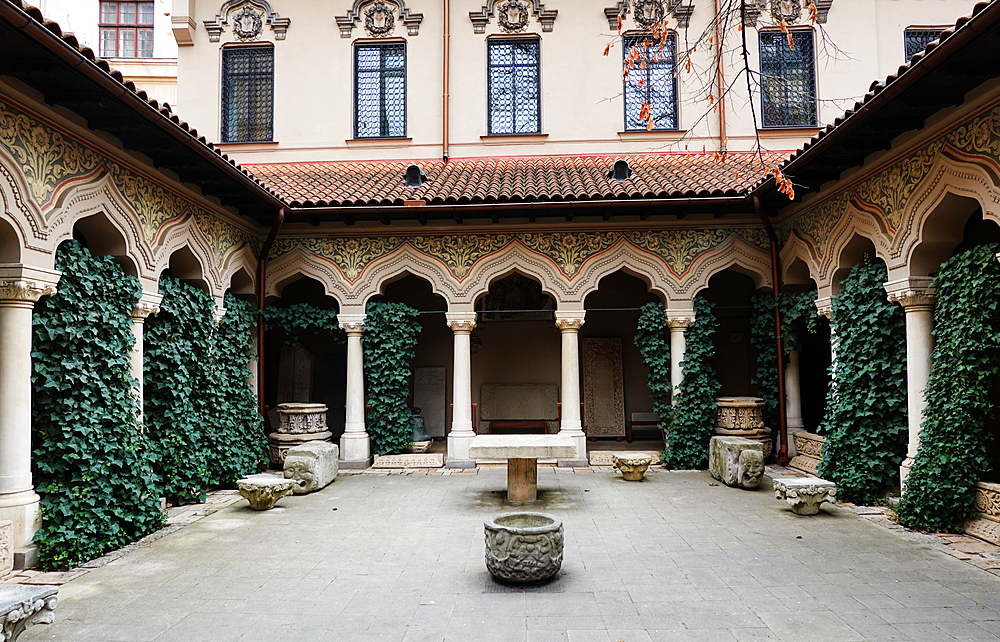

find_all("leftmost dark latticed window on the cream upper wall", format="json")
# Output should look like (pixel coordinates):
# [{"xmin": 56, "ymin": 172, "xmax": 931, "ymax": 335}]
[{"xmin": 222, "ymin": 46, "xmax": 274, "ymax": 143}]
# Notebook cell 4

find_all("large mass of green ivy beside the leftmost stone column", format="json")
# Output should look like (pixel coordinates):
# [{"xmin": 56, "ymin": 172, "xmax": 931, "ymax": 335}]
[{"xmin": 31, "ymin": 241, "xmax": 163, "ymax": 569}]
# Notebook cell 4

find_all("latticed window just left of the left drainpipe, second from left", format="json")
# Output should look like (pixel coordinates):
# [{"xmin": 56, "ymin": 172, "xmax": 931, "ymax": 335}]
[{"xmin": 354, "ymin": 42, "xmax": 406, "ymax": 138}]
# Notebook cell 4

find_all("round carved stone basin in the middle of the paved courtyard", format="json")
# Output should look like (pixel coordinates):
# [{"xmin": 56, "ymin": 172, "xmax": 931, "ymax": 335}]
[{"xmin": 484, "ymin": 512, "xmax": 563, "ymax": 584}]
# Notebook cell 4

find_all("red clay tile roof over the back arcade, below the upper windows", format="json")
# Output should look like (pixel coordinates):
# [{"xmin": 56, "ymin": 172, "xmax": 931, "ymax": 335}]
[{"xmin": 244, "ymin": 152, "xmax": 787, "ymax": 207}]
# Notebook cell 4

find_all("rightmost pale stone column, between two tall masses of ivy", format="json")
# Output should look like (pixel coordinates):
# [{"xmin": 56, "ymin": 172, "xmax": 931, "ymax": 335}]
[{"xmin": 885, "ymin": 277, "xmax": 937, "ymax": 487}]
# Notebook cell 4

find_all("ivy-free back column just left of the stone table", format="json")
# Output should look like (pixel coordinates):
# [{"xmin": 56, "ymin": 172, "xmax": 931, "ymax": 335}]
[{"xmin": 445, "ymin": 312, "xmax": 476, "ymax": 468}]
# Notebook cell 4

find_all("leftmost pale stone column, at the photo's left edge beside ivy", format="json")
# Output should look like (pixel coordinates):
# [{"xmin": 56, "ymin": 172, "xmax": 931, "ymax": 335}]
[{"xmin": 0, "ymin": 265, "xmax": 59, "ymax": 548}]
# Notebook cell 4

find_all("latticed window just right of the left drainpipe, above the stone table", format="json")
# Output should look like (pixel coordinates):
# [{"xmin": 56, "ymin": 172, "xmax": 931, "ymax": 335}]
[{"xmin": 487, "ymin": 38, "xmax": 542, "ymax": 135}]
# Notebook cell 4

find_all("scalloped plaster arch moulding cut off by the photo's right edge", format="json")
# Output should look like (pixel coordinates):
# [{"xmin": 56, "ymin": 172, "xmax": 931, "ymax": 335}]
[{"xmin": 887, "ymin": 154, "xmax": 1000, "ymax": 276}]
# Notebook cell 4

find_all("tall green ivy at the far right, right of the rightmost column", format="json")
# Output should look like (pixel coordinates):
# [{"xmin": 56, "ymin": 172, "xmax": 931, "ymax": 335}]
[{"xmin": 897, "ymin": 244, "xmax": 1000, "ymax": 532}]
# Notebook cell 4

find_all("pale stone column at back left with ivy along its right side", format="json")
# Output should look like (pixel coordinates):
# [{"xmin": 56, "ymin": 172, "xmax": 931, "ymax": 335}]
[{"xmin": 339, "ymin": 314, "xmax": 371, "ymax": 468}]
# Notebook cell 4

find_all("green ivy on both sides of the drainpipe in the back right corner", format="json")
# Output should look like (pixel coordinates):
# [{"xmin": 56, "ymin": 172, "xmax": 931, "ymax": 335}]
[{"xmin": 750, "ymin": 290, "xmax": 821, "ymax": 429}]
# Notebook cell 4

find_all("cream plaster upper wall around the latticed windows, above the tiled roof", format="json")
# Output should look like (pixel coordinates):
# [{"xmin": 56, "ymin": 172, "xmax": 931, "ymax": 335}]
[{"xmin": 175, "ymin": 0, "xmax": 972, "ymax": 163}]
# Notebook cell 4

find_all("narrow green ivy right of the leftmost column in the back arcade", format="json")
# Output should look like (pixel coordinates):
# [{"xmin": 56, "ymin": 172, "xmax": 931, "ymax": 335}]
[{"xmin": 364, "ymin": 302, "xmax": 420, "ymax": 455}]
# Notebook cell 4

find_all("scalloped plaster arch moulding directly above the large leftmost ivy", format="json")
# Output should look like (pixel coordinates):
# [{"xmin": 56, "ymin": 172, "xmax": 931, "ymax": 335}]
[{"xmin": 48, "ymin": 173, "xmax": 159, "ymax": 282}]
